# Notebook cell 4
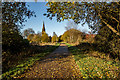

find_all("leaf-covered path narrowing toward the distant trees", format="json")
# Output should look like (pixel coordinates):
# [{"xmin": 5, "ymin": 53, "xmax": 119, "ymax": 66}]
[{"xmin": 19, "ymin": 44, "xmax": 81, "ymax": 79}]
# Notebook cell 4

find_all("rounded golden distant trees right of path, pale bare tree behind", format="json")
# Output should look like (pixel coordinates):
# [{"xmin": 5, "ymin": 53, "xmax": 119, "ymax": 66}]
[{"xmin": 61, "ymin": 21, "xmax": 95, "ymax": 44}]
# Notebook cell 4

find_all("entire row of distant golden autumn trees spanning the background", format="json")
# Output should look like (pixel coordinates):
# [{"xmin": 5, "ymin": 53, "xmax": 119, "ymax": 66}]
[{"xmin": 23, "ymin": 21, "xmax": 95, "ymax": 45}]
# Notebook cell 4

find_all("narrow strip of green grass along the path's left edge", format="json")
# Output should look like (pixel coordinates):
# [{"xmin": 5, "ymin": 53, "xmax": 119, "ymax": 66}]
[{"xmin": 1, "ymin": 43, "xmax": 60, "ymax": 79}]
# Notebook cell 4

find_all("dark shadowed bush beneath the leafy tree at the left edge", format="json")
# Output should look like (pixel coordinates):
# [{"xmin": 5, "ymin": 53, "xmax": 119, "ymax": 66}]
[{"xmin": 2, "ymin": 33, "xmax": 29, "ymax": 54}]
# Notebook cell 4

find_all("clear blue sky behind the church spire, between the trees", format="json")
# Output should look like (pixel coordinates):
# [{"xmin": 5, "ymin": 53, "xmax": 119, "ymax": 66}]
[{"xmin": 21, "ymin": 2, "xmax": 90, "ymax": 36}]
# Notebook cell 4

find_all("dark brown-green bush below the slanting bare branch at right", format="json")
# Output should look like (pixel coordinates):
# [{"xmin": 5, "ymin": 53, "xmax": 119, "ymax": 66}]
[{"xmin": 95, "ymin": 26, "xmax": 120, "ymax": 58}]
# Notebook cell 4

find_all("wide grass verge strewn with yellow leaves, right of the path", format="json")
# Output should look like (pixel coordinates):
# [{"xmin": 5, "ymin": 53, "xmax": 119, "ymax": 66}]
[{"xmin": 67, "ymin": 44, "xmax": 120, "ymax": 80}]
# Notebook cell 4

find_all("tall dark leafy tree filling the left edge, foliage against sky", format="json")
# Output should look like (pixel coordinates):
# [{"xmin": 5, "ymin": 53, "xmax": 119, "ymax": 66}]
[{"xmin": 2, "ymin": 2, "xmax": 35, "ymax": 53}]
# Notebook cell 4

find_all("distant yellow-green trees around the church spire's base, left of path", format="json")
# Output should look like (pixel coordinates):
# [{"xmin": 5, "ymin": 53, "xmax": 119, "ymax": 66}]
[{"xmin": 23, "ymin": 28, "xmax": 59, "ymax": 44}]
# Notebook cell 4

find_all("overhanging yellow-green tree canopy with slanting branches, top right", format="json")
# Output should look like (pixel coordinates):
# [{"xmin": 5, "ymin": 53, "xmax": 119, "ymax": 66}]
[{"xmin": 44, "ymin": 2, "xmax": 120, "ymax": 36}]
